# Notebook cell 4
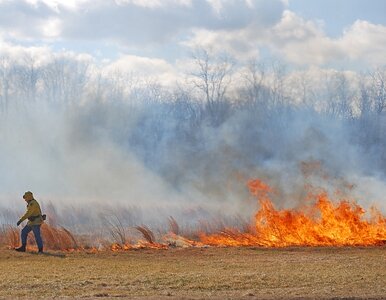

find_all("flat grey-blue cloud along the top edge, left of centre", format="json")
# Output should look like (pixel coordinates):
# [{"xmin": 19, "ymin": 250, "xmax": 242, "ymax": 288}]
[{"xmin": 62, "ymin": 0, "xmax": 281, "ymax": 47}]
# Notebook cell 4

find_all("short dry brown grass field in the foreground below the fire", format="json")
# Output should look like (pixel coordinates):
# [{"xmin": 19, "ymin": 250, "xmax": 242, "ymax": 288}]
[{"xmin": 0, "ymin": 247, "xmax": 386, "ymax": 299}]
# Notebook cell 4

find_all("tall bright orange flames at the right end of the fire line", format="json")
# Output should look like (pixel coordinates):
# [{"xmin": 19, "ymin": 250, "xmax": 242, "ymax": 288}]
[{"xmin": 200, "ymin": 180, "xmax": 386, "ymax": 247}]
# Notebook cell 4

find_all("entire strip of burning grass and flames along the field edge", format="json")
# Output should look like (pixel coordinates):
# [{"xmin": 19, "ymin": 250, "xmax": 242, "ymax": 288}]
[{"xmin": 0, "ymin": 180, "xmax": 386, "ymax": 251}]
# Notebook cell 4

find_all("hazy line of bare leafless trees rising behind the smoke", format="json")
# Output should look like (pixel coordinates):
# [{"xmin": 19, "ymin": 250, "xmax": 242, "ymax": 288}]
[{"xmin": 0, "ymin": 49, "xmax": 386, "ymax": 182}]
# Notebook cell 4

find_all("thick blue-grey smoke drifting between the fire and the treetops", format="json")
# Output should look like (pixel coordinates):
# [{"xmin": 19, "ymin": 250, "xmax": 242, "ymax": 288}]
[{"xmin": 0, "ymin": 55, "xmax": 386, "ymax": 232}]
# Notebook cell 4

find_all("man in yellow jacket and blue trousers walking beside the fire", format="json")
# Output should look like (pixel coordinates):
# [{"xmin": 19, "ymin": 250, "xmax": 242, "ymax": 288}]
[{"xmin": 15, "ymin": 192, "xmax": 44, "ymax": 253}]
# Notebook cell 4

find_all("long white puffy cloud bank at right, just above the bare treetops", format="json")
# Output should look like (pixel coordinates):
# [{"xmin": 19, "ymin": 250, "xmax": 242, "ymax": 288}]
[{"xmin": 181, "ymin": 10, "xmax": 386, "ymax": 68}]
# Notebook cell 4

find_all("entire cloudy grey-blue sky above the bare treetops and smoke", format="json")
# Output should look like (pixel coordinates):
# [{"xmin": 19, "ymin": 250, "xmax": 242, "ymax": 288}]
[{"xmin": 0, "ymin": 0, "xmax": 386, "ymax": 75}]
